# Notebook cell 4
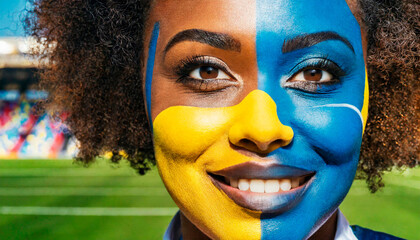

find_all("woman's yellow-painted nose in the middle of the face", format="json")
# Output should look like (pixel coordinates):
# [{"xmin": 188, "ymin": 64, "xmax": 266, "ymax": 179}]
[{"xmin": 229, "ymin": 90, "xmax": 293, "ymax": 154}]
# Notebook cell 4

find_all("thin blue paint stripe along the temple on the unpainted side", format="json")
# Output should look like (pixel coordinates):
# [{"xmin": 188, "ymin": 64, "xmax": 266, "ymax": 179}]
[{"xmin": 145, "ymin": 22, "xmax": 159, "ymax": 129}]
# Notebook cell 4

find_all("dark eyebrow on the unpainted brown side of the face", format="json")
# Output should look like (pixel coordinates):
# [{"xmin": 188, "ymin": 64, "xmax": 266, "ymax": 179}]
[{"xmin": 164, "ymin": 29, "xmax": 241, "ymax": 54}]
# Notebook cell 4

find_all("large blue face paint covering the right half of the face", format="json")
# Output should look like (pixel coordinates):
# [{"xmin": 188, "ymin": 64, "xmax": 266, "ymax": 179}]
[{"xmin": 256, "ymin": 0, "xmax": 365, "ymax": 239}]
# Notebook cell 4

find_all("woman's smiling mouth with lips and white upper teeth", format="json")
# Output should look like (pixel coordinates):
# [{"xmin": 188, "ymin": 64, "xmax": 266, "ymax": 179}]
[{"xmin": 208, "ymin": 162, "xmax": 315, "ymax": 213}]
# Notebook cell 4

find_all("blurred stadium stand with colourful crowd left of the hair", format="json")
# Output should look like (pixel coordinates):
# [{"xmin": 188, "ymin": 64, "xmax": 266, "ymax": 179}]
[{"xmin": 0, "ymin": 37, "xmax": 77, "ymax": 159}]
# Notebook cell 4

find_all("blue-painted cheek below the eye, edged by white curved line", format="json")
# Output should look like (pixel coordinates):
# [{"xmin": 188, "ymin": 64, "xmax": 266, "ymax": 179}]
[{"xmin": 295, "ymin": 107, "xmax": 363, "ymax": 165}]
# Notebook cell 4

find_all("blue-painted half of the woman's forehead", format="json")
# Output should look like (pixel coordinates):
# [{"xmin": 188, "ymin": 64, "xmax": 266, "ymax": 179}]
[{"xmin": 256, "ymin": 0, "xmax": 358, "ymax": 36}]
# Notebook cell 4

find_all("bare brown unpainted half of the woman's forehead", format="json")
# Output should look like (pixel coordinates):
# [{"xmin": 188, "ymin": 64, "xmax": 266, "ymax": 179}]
[{"xmin": 147, "ymin": 0, "xmax": 256, "ymax": 45}]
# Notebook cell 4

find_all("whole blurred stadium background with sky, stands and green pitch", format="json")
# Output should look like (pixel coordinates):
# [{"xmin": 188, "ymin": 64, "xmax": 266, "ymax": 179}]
[{"xmin": 0, "ymin": 0, "xmax": 420, "ymax": 240}]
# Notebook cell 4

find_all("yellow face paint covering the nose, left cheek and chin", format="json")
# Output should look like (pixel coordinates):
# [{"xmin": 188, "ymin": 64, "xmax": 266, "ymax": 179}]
[{"xmin": 153, "ymin": 90, "xmax": 293, "ymax": 239}]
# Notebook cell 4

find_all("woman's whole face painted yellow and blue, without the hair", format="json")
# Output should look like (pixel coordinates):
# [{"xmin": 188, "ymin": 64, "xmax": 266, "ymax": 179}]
[{"xmin": 145, "ymin": 0, "xmax": 368, "ymax": 239}]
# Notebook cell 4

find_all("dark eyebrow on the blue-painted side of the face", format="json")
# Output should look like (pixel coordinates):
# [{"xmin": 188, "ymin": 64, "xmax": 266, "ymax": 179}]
[{"xmin": 281, "ymin": 31, "xmax": 354, "ymax": 53}]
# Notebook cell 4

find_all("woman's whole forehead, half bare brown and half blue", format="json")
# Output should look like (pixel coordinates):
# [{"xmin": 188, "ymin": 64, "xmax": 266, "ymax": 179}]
[{"xmin": 148, "ymin": 0, "xmax": 356, "ymax": 37}]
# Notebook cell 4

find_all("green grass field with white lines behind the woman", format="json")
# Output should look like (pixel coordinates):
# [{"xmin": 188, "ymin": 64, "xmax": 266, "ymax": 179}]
[{"xmin": 0, "ymin": 160, "xmax": 420, "ymax": 240}]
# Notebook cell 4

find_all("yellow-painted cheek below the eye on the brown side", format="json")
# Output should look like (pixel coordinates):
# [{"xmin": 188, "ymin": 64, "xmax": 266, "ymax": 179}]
[{"xmin": 153, "ymin": 106, "xmax": 230, "ymax": 161}]
